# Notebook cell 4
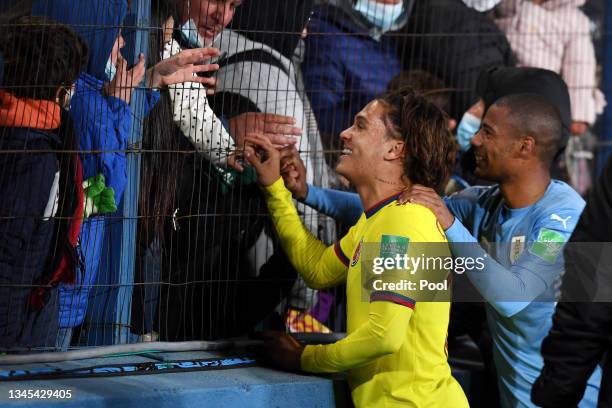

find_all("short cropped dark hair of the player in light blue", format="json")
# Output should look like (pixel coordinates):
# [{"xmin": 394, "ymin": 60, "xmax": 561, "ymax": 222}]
[{"xmin": 493, "ymin": 93, "xmax": 563, "ymax": 166}]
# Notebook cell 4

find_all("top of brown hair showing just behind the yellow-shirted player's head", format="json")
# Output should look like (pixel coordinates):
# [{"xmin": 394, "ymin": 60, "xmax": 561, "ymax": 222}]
[{"xmin": 387, "ymin": 69, "xmax": 451, "ymax": 114}]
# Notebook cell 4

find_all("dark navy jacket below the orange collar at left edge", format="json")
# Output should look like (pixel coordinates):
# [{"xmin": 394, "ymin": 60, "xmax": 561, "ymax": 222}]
[{"xmin": 0, "ymin": 128, "xmax": 60, "ymax": 349}]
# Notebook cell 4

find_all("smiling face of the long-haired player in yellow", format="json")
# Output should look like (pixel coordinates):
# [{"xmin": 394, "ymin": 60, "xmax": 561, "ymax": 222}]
[{"xmin": 336, "ymin": 100, "xmax": 391, "ymax": 185}]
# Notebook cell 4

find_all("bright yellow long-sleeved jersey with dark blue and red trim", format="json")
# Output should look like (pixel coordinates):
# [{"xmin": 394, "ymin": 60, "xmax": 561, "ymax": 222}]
[{"xmin": 264, "ymin": 179, "xmax": 468, "ymax": 408}]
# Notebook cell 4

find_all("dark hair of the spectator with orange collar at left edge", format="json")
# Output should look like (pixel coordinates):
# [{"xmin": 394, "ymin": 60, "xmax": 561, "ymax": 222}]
[{"xmin": 0, "ymin": 16, "xmax": 88, "ymax": 100}]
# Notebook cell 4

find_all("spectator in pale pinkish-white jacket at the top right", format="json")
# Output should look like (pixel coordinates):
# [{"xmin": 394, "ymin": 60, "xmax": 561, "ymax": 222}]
[{"xmin": 495, "ymin": 0, "xmax": 606, "ymax": 135}]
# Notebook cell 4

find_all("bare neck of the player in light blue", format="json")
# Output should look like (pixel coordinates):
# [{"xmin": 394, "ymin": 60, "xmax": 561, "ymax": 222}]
[{"xmin": 499, "ymin": 168, "xmax": 551, "ymax": 208}]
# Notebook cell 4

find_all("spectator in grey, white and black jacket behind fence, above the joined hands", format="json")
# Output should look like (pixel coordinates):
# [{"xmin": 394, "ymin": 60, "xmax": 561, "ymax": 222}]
[{"xmin": 214, "ymin": 0, "xmax": 335, "ymax": 330}]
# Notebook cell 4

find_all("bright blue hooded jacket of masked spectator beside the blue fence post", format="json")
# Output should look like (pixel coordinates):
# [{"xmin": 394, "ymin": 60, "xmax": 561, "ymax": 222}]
[{"xmin": 32, "ymin": 0, "xmax": 159, "ymax": 328}]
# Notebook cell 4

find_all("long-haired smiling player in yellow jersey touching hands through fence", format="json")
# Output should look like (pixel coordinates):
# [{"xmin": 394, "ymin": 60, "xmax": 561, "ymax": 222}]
[{"xmin": 246, "ymin": 91, "xmax": 468, "ymax": 407}]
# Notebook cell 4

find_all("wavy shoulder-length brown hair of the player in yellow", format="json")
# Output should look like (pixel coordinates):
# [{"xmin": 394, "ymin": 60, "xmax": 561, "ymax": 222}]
[{"xmin": 378, "ymin": 88, "xmax": 456, "ymax": 193}]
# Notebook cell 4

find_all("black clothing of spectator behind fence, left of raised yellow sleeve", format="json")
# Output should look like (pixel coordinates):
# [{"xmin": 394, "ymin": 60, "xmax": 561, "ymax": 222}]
[{"xmin": 155, "ymin": 135, "xmax": 295, "ymax": 341}]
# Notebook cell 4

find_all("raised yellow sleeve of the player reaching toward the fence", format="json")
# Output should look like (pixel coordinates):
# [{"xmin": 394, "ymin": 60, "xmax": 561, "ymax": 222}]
[{"xmin": 263, "ymin": 178, "xmax": 351, "ymax": 289}]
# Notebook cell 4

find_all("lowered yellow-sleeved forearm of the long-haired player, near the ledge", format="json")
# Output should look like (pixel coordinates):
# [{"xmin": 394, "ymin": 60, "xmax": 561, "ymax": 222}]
[{"xmin": 301, "ymin": 302, "xmax": 412, "ymax": 373}]
